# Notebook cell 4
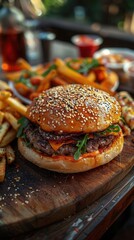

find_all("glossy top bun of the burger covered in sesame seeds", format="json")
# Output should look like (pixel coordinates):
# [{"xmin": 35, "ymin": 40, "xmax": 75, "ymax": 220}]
[{"xmin": 27, "ymin": 84, "xmax": 121, "ymax": 133}]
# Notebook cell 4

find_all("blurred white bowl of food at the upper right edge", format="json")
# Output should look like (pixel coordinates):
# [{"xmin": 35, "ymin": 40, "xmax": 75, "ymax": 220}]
[{"xmin": 94, "ymin": 48, "xmax": 134, "ymax": 70}]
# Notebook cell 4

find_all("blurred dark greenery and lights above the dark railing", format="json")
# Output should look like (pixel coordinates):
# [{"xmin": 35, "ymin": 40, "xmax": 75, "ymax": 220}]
[{"xmin": 15, "ymin": 0, "xmax": 134, "ymax": 34}]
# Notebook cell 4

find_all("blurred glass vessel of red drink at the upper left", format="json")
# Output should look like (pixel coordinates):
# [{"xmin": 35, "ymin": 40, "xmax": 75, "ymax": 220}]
[{"xmin": 0, "ymin": 0, "xmax": 26, "ymax": 72}]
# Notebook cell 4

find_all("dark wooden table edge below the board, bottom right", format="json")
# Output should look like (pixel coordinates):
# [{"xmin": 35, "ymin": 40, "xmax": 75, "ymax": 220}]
[{"xmin": 9, "ymin": 169, "xmax": 134, "ymax": 240}]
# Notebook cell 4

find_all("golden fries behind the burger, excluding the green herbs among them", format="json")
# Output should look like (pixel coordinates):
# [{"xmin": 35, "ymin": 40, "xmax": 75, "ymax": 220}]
[{"xmin": 6, "ymin": 58, "xmax": 115, "ymax": 100}]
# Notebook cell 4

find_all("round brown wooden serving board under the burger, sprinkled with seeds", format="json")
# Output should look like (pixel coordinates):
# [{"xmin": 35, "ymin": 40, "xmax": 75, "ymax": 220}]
[{"xmin": 0, "ymin": 133, "xmax": 134, "ymax": 239}]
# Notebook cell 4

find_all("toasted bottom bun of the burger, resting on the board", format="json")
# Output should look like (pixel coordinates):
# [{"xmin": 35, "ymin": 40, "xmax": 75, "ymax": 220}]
[{"xmin": 18, "ymin": 132, "xmax": 124, "ymax": 173}]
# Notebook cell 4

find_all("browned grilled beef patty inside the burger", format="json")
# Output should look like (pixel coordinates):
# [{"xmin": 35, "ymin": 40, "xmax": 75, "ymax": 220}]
[{"xmin": 24, "ymin": 122, "xmax": 115, "ymax": 156}]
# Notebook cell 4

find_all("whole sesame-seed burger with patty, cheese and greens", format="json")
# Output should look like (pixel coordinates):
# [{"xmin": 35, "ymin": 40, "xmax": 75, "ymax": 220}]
[{"xmin": 18, "ymin": 84, "xmax": 124, "ymax": 173}]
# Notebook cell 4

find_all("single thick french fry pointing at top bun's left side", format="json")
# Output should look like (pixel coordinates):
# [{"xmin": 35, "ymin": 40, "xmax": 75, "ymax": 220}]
[{"xmin": 5, "ymin": 97, "xmax": 27, "ymax": 116}]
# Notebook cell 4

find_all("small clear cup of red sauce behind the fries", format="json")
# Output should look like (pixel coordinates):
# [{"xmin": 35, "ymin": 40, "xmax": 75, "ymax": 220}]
[{"xmin": 71, "ymin": 34, "xmax": 103, "ymax": 57}]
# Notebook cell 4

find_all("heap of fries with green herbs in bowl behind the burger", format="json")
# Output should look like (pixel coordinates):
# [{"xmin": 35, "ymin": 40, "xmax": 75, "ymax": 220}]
[{"xmin": 6, "ymin": 58, "xmax": 118, "ymax": 101}]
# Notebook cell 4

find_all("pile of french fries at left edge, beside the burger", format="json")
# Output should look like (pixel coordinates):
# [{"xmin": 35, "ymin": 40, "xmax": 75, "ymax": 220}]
[{"xmin": 0, "ymin": 81, "xmax": 27, "ymax": 182}]
